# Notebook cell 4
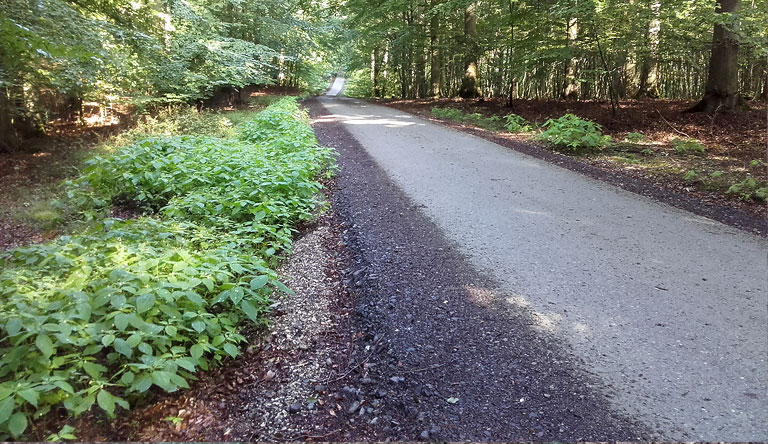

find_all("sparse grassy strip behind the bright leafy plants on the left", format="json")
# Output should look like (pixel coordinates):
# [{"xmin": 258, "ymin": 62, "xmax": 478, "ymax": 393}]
[{"xmin": 0, "ymin": 93, "xmax": 282, "ymax": 250}]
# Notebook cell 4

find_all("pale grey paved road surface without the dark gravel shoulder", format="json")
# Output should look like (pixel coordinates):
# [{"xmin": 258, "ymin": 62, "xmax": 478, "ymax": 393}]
[{"xmin": 320, "ymin": 78, "xmax": 768, "ymax": 441}]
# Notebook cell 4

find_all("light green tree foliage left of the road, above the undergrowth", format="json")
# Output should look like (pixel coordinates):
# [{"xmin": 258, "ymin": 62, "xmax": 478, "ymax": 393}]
[{"xmin": 0, "ymin": 0, "xmax": 336, "ymax": 151}]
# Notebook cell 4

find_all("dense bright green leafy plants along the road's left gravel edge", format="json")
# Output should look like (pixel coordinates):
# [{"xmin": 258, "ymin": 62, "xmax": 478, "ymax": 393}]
[{"xmin": 0, "ymin": 98, "xmax": 333, "ymax": 439}]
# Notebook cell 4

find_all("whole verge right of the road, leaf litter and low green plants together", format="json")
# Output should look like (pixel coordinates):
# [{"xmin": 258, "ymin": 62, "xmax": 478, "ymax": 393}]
[{"xmin": 414, "ymin": 99, "xmax": 768, "ymax": 206}]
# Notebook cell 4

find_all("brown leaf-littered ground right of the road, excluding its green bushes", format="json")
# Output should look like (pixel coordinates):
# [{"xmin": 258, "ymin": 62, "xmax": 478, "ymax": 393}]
[{"xmin": 377, "ymin": 99, "xmax": 768, "ymax": 231}]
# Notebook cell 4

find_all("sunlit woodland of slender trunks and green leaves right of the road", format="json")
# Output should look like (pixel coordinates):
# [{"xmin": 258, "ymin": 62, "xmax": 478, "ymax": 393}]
[{"xmin": 347, "ymin": 0, "xmax": 768, "ymax": 106}]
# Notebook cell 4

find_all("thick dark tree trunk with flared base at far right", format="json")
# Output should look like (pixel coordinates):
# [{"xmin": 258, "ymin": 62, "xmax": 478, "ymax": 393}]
[{"xmin": 687, "ymin": 0, "xmax": 749, "ymax": 113}]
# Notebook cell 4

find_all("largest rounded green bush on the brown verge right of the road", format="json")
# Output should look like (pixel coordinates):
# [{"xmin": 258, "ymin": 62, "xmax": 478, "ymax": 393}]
[{"xmin": 538, "ymin": 114, "xmax": 611, "ymax": 151}]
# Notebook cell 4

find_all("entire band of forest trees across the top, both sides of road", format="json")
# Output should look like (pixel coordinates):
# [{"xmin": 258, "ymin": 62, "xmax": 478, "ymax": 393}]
[{"xmin": 0, "ymin": 0, "xmax": 768, "ymax": 152}]
